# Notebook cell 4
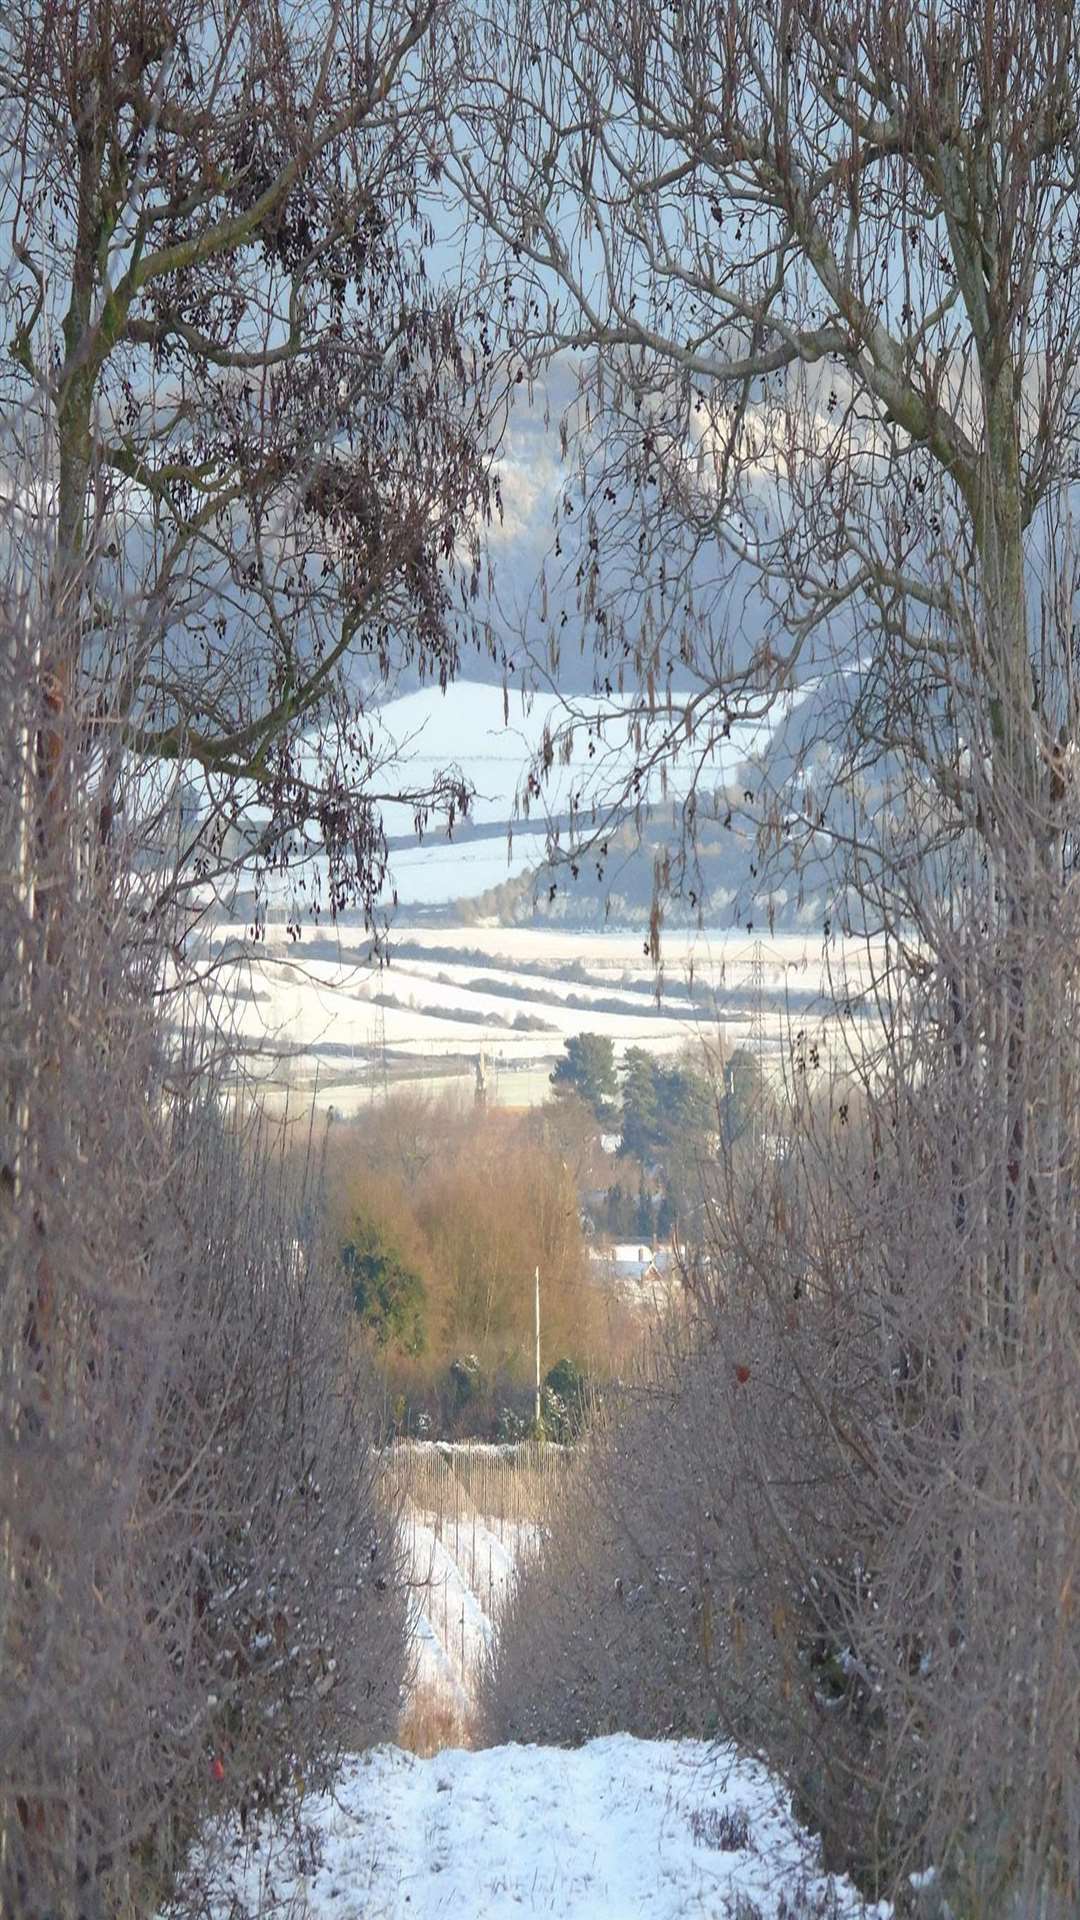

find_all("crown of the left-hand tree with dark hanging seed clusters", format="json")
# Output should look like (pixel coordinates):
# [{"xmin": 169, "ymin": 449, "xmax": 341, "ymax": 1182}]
[{"xmin": 0, "ymin": 0, "xmax": 496, "ymax": 929}]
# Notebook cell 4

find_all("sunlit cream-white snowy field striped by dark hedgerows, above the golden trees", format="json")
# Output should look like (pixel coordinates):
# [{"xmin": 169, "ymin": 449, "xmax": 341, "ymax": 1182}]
[{"xmin": 197, "ymin": 924, "xmax": 882, "ymax": 1116}]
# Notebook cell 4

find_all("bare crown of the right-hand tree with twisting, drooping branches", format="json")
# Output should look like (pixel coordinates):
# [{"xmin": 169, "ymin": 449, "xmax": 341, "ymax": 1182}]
[{"xmin": 444, "ymin": 0, "xmax": 1080, "ymax": 921}]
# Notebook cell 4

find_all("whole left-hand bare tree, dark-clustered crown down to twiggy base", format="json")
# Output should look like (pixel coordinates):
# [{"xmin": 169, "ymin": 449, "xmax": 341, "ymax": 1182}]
[{"xmin": 0, "ymin": 11, "xmax": 494, "ymax": 1920}]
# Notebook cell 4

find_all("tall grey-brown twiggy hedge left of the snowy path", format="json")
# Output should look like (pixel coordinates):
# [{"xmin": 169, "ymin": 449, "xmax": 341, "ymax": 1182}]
[{"xmin": 0, "ymin": 453, "xmax": 407, "ymax": 1920}]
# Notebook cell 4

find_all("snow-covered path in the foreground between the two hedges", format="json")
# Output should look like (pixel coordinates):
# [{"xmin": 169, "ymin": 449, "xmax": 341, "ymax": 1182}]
[{"xmin": 187, "ymin": 1734, "xmax": 886, "ymax": 1920}]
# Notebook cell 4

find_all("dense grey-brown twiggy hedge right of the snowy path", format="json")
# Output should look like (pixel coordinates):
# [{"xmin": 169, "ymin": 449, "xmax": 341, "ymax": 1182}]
[{"xmin": 482, "ymin": 893, "xmax": 1080, "ymax": 1920}]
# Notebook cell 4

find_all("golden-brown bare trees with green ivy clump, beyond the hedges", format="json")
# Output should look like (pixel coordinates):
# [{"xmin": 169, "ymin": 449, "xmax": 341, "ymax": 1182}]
[{"xmin": 315, "ymin": 1092, "xmax": 632, "ymax": 1438}]
